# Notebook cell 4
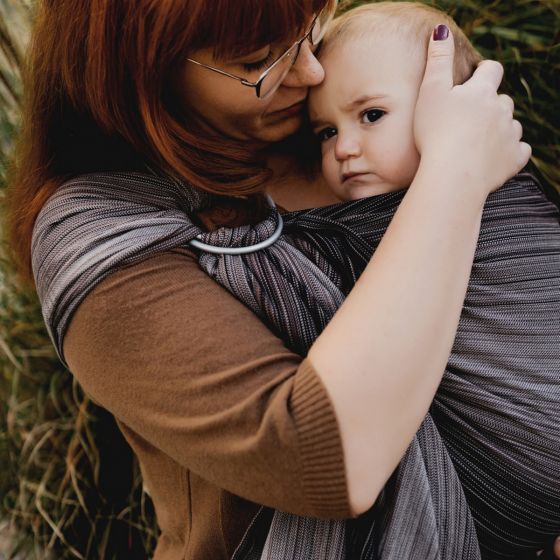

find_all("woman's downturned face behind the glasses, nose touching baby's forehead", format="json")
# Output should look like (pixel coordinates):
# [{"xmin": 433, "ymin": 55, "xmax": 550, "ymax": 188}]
[{"xmin": 178, "ymin": 40, "xmax": 324, "ymax": 143}]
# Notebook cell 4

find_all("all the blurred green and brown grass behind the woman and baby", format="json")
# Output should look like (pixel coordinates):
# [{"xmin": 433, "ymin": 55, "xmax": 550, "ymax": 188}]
[{"xmin": 0, "ymin": 0, "xmax": 560, "ymax": 560}]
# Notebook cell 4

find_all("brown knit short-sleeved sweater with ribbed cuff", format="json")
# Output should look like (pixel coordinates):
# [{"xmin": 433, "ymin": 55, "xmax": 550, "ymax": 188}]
[{"xmin": 64, "ymin": 249, "xmax": 350, "ymax": 560}]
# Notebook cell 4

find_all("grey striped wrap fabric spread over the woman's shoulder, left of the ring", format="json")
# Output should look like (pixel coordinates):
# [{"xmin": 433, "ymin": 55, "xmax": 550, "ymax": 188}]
[{"xmin": 31, "ymin": 172, "xmax": 206, "ymax": 355}]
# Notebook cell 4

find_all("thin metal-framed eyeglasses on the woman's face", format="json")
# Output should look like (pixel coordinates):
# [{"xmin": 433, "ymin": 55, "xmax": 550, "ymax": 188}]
[{"xmin": 187, "ymin": 2, "xmax": 337, "ymax": 99}]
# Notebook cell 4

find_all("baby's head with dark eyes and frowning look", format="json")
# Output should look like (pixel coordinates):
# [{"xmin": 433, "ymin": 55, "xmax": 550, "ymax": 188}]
[{"xmin": 309, "ymin": 2, "xmax": 481, "ymax": 200}]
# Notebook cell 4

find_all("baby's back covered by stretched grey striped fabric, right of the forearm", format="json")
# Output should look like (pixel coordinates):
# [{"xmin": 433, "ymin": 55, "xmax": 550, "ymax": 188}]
[{"xmin": 432, "ymin": 175, "xmax": 560, "ymax": 558}]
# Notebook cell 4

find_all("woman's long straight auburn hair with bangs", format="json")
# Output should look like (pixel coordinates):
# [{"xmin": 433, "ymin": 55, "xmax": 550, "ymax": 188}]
[{"xmin": 6, "ymin": 0, "xmax": 333, "ymax": 280}]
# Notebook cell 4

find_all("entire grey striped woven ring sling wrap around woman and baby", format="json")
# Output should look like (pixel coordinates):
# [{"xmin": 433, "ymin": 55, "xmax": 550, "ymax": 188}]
[{"xmin": 32, "ymin": 173, "xmax": 560, "ymax": 560}]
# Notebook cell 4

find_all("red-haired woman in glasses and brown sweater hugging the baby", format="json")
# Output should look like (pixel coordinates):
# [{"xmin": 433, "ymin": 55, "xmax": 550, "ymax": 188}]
[{"xmin": 6, "ymin": 0, "xmax": 556, "ymax": 560}]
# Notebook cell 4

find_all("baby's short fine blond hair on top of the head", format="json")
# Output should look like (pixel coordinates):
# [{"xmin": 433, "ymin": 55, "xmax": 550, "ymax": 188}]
[{"xmin": 320, "ymin": 2, "xmax": 482, "ymax": 84}]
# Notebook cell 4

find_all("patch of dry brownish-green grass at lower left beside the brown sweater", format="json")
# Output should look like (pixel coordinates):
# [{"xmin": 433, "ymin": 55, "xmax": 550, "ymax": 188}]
[{"xmin": 0, "ymin": 245, "xmax": 157, "ymax": 560}]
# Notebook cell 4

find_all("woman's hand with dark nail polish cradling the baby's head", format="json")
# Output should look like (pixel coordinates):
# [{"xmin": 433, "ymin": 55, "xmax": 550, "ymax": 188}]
[{"xmin": 414, "ymin": 26, "xmax": 531, "ymax": 199}]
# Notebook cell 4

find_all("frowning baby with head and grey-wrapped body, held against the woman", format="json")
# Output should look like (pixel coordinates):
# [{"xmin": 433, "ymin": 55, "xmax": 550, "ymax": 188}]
[{"xmin": 309, "ymin": 2, "xmax": 560, "ymax": 559}]
